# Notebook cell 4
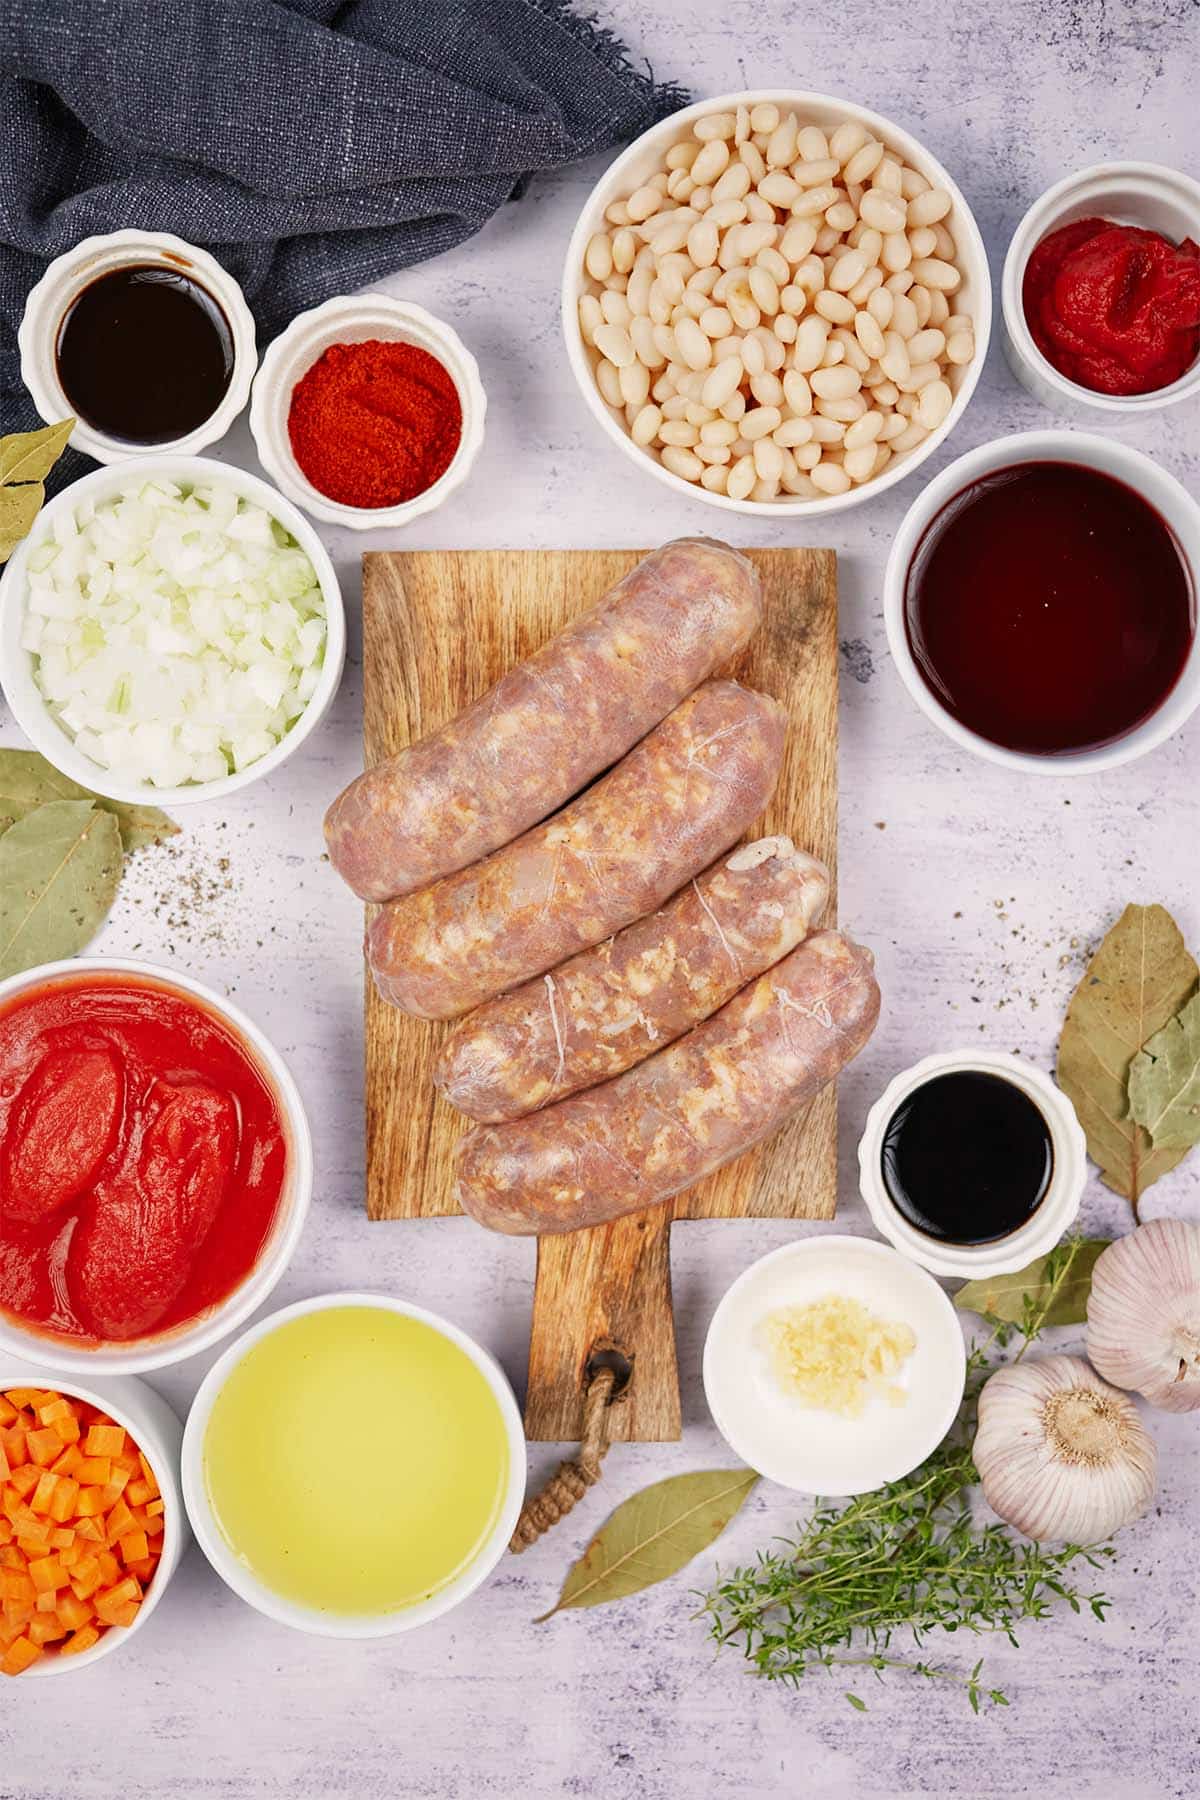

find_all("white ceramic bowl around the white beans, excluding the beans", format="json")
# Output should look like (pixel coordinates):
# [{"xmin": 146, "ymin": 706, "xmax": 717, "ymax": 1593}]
[{"xmin": 561, "ymin": 88, "xmax": 991, "ymax": 518}]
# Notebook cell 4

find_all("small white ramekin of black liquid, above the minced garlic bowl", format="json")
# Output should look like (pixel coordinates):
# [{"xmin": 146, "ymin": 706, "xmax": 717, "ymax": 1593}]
[{"xmin": 858, "ymin": 1049, "xmax": 1087, "ymax": 1276}]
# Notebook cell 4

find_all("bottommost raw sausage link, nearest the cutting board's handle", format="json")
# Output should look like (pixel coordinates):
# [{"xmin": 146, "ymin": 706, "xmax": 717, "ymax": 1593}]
[{"xmin": 457, "ymin": 931, "xmax": 880, "ymax": 1237}]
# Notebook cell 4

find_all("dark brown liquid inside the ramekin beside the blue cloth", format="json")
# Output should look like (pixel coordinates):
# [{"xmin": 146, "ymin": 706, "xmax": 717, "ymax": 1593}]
[{"xmin": 54, "ymin": 263, "xmax": 234, "ymax": 445}]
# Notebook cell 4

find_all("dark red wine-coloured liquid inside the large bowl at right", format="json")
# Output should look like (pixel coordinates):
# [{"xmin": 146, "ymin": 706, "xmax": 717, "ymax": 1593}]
[{"xmin": 905, "ymin": 463, "xmax": 1196, "ymax": 756}]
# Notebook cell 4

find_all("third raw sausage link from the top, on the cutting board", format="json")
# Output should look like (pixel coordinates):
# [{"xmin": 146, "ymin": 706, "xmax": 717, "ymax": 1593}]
[{"xmin": 434, "ymin": 837, "xmax": 829, "ymax": 1123}]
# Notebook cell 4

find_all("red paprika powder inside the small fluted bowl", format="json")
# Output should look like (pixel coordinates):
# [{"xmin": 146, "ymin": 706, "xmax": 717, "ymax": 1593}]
[{"xmin": 288, "ymin": 338, "xmax": 462, "ymax": 508}]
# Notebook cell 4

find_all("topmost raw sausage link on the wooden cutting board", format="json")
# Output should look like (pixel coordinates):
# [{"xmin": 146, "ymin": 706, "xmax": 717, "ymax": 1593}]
[{"xmin": 326, "ymin": 538, "xmax": 763, "ymax": 900}]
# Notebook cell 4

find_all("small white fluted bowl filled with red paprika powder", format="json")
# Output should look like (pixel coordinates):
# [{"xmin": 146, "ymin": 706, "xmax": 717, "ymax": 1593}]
[{"xmin": 250, "ymin": 293, "xmax": 488, "ymax": 531}]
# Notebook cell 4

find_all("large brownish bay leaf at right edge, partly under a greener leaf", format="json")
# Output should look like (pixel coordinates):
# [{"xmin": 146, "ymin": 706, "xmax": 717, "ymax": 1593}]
[{"xmin": 1058, "ymin": 905, "xmax": 1200, "ymax": 1217}]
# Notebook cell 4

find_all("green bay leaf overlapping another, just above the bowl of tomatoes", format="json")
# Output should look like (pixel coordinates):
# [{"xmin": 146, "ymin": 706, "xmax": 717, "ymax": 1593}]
[{"xmin": 0, "ymin": 799, "xmax": 124, "ymax": 977}]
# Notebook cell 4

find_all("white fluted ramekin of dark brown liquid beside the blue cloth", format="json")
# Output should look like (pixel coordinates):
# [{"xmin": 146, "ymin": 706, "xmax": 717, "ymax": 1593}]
[{"xmin": 20, "ymin": 230, "xmax": 257, "ymax": 463}]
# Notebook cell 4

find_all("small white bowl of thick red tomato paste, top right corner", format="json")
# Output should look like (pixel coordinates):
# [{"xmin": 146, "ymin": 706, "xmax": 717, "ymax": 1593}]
[{"xmin": 1000, "ymin": 162, "xmax": 1200, "ymax": 419}]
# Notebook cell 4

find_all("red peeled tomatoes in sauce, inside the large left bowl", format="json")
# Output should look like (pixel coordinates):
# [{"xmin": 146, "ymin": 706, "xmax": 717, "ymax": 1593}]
[{"xmin": 0, "ymin": 974, "xmax": 288, "ymax": 1343}]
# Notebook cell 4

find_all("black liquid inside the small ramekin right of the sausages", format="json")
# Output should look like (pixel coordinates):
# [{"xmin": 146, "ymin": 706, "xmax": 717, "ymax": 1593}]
[{"xmin": 882, "ymin": 1069, "xmax": 1054, "ymax": 1244}]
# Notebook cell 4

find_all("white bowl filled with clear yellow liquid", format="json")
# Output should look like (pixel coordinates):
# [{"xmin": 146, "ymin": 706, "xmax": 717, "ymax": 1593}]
[{"xmin": 184, "ymin": 1294, "xmax": 525, "ymax": 1638}]
